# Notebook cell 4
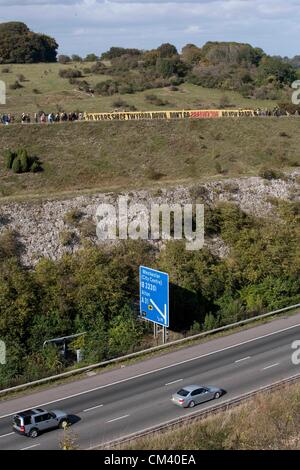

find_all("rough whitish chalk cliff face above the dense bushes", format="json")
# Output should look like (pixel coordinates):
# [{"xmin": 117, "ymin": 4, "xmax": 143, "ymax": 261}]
[{"xmin": 0, "ymin": 170, "xmax": 300, "ymax": 266}]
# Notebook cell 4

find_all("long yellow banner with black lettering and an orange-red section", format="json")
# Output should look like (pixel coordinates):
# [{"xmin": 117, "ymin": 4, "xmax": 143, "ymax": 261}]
[{"xmin": 84, "ymin": 109, "xmax": 256, "ymax": 121}]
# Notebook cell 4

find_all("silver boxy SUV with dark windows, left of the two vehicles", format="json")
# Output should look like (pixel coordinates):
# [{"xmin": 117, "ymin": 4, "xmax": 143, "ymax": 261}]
[{"xmin": 13, "ymin": 408, "xmax": 69, "ymax": 438}]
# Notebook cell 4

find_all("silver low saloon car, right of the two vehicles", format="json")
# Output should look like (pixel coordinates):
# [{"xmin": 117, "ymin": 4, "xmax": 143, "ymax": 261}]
[{"xmin": 172, "ymin": 385, "xmax": 223, "ymax": 408}]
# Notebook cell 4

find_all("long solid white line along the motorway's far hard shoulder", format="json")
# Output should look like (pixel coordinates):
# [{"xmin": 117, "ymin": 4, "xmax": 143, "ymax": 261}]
[{"xmin": 0, "ymin": 323, "xmax": 300, "ymax": 419}]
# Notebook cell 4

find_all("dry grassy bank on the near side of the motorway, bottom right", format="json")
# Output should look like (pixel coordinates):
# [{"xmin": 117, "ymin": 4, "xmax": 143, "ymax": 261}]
[{"xmin": 122, "ymin": 384, "xmax": 300, "ymax": 450}]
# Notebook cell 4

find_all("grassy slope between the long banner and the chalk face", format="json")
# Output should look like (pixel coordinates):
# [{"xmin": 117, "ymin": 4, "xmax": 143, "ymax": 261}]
[{"xmin": 0, "ymin": 118, "xmax": 300, "ymax": 200}]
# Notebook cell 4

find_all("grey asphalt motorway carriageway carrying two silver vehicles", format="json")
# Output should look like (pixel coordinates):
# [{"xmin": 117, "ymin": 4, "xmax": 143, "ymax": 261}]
[{"xmin": 0, "ymin": 313, "xmax": 300, "ymax": 450}]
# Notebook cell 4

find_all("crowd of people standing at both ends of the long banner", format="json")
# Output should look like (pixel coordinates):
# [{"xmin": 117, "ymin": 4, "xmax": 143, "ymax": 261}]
[{"xmin": 0, "ymin": 107, "xmax": 300, "ymax": 125}]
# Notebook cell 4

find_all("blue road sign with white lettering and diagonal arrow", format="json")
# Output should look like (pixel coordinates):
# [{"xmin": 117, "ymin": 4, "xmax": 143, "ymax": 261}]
[{"xmin": 140, "ymin": 266, "xmax": 169, "ymax": 327}]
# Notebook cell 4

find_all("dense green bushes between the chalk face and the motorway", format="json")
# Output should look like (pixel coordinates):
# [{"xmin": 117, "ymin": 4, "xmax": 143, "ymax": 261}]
[{"xmin": 0, "ymin": 201, "xmax": 300, "ymax": 387}]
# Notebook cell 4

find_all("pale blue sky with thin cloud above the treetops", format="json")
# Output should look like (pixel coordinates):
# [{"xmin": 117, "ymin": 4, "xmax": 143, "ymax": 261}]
[{"xmin": 0, "ymin": 0, "xmax": 300, "ymax": 57}]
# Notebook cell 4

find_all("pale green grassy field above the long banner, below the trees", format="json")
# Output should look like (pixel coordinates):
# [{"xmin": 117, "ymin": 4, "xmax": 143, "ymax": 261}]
[{"xmin": 0, "ymin": 62, "xmax": 276, "ymax": 114}]
